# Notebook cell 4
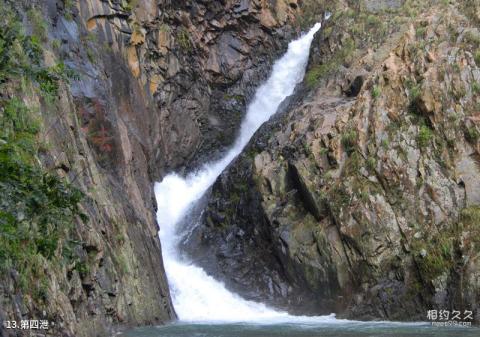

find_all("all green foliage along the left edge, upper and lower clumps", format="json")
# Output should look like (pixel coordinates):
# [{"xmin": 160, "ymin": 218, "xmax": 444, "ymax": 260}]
[{"xmin": 0, "ymin": 3, "xmax": 82, "ymax": 301}]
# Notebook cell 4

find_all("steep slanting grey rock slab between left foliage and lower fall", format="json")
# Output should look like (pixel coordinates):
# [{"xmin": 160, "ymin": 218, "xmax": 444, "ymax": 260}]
[{"xmin": 1, "ymin": 1, "xmax": 175, "ymax": 336}]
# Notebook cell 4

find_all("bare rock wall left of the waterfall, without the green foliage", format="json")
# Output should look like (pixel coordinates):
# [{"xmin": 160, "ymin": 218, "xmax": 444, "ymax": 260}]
[{"xmin": 0, "ymin": 0, "xmax": 308, "ymax": 336}]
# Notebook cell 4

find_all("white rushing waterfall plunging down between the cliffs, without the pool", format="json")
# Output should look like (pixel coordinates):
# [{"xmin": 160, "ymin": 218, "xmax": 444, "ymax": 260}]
[{"xmin": 155, "ymin": 23, "xmax": 326, "ymax": 323}]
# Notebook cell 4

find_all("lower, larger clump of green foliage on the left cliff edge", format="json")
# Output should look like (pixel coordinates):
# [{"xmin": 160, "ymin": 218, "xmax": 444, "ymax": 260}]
[{"xmin": 0, "ymin": 98, "xmax": 83, "ymax": 288}]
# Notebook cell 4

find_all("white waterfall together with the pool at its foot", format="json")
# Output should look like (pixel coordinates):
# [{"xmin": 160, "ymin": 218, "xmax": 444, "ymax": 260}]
[{"xmin": 125, "ymin": 23, "xmax": 473, "ymax": 337}]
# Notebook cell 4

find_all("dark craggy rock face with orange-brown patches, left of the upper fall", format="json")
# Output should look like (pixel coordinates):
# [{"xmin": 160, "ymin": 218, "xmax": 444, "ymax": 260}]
[{"xmin": 81, "ymin": 0, "xmax": 298, "ymax": 176}]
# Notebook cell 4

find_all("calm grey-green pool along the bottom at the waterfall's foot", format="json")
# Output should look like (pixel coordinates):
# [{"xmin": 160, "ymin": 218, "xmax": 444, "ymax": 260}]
[{"xmin": 121, "ymin": 322, "xmax": 480, "ymax": 337}]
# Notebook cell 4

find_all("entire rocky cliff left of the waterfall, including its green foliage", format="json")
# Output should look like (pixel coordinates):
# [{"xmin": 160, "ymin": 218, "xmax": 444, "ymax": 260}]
[{"xmin": 0, "ymin": 0, "xmax": 301, "ymax": 336}]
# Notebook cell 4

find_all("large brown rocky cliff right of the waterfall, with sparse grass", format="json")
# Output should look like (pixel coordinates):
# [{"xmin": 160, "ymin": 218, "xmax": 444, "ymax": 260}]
[{"xmin": 187, "ymin": 0, "xmax": 480, "ymax": 320}]
